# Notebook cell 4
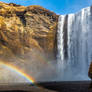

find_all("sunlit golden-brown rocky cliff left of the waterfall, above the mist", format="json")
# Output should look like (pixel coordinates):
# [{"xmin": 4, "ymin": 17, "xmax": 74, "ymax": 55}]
[{"xmin": 0, "ymin": 2, "xmax": 58, "ymax": 59}]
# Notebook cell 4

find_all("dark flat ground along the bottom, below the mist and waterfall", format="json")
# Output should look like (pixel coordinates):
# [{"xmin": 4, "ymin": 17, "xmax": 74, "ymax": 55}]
[{"xmin": 0, "ymin": 81, "xmax": 92, "ymax": 92}]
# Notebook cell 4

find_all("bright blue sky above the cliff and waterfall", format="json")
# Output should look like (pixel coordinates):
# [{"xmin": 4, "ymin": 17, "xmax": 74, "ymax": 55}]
[{"xmin": 0, "ymin": 0, "xmax": 92, "ymax": 14}]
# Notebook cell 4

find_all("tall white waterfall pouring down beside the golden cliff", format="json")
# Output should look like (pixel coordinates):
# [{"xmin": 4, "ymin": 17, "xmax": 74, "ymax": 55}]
[{"xmin": 57, "ymin": 7, "xmax": 92, "ymax": 81}]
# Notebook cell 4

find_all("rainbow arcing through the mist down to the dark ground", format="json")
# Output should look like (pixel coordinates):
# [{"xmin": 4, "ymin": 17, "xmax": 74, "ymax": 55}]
[{"xmin": 0, "ymin": 62, "xmax": 35, "ymax": 84}]
